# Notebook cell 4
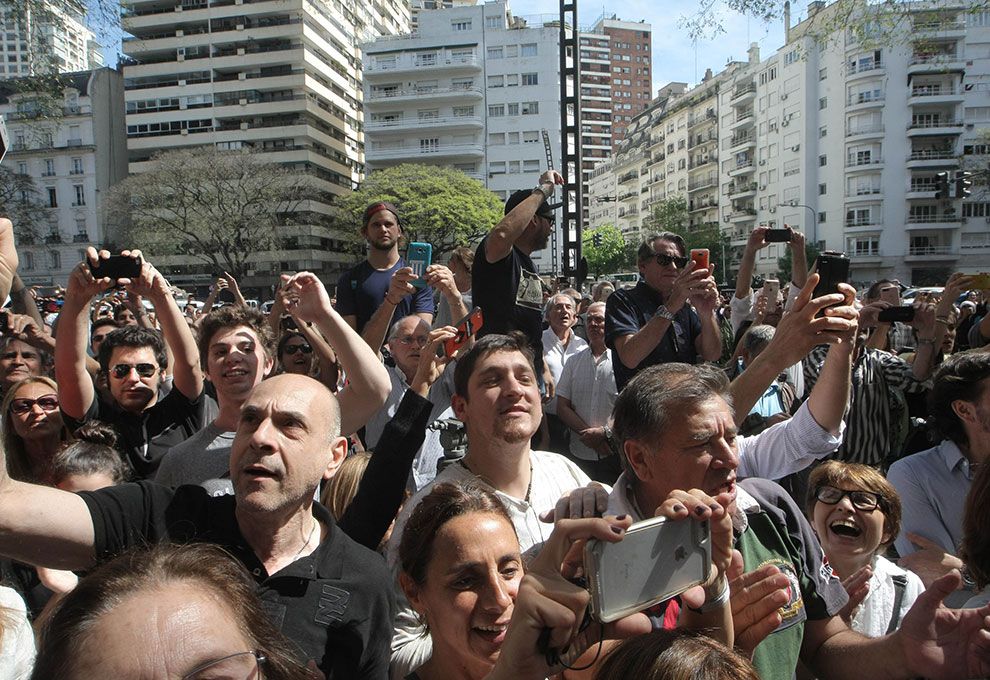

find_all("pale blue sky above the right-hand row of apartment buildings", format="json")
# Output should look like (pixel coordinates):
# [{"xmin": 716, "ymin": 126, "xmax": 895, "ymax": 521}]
[{"xmin": 524, "ymin": 0, "xmax": 806, "ymax": 94}]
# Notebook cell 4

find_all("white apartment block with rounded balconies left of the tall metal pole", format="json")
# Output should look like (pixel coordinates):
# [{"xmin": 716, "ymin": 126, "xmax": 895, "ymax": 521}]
[{"xmin": 362, "ymin": 0, "xmax": 560, "ymax": 272}]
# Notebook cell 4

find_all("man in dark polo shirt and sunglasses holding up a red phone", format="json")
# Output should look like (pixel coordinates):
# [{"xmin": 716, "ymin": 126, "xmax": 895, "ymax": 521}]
[{"xmin": 605, "ymin": 232, "xmax": 722, "ymax": 392}]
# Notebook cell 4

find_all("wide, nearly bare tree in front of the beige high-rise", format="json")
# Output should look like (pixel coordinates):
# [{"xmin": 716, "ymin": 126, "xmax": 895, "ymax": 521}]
[{"xmin": 104, "ymin": 146, "xmax": 310, "ymax": 279}]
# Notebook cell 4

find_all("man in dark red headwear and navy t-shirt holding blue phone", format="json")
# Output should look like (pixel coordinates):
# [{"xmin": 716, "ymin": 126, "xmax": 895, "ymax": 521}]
[{"xmin": 336, "ymin": 202, "xmax": 433, "ymax": 342}]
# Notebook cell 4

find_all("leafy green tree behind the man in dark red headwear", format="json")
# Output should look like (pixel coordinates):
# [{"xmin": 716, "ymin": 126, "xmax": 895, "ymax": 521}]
[{"xmin": 336, "ymin": 163, "xmax": 503, "ymax": 260}]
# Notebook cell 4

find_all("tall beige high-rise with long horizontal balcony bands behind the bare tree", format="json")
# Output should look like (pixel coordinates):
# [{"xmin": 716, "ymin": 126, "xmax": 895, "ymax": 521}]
[{"xmin": 123, "ymin": 0, "xmax": 409, "ymax": 288}]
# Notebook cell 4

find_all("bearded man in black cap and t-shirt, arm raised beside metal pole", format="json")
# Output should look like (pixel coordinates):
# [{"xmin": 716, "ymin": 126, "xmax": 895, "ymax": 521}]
[{"xmin": 471, "ymin": 170, "xmax": 564, "ymax": 396}]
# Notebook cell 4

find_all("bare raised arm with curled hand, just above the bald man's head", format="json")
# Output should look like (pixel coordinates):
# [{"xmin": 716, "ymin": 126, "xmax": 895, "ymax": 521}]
[{"xmin": 283, "ymin": 272, "xmax": 392, "ymax": 436}]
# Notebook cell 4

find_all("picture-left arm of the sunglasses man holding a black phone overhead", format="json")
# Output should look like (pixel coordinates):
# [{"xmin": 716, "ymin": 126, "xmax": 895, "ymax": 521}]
[{"xmin": 55, "ymin": 247, "xmax": 114, "ymax": 420}]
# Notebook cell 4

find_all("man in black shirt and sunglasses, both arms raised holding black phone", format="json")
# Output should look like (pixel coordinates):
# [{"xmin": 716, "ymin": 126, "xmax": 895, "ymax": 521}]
[{"xmin": 55, "ymin": 247, "xmax": 206, "ymax": 478}]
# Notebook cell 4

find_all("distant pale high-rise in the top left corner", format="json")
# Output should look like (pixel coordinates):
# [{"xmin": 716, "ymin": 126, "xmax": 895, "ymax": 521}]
[{"xmin": 0, "ymin": 0, "xmax": 103, "ymax": 80}]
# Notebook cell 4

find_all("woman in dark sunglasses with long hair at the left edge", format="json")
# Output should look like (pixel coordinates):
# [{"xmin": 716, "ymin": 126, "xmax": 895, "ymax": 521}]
[{"xmin": 2, "ymin": 376, "xmax": 71, "ymax": 485}]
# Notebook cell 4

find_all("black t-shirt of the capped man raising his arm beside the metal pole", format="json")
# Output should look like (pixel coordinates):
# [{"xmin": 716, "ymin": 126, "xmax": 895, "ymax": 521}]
[{"xmin": 471, "ymin": 236, "xmax": 543, "ymax": 375}]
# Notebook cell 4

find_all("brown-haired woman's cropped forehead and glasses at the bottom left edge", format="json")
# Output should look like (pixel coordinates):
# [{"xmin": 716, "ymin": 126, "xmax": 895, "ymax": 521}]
[{"xmin": 32, "ymin": 544, "xmax": 315, "ymax": 680}]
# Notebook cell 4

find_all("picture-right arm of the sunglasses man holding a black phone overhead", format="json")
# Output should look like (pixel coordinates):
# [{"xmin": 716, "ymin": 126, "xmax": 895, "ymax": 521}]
[{"xmin": 127, "ymin": 250, "xmax": 203, "ymax": 400}]
